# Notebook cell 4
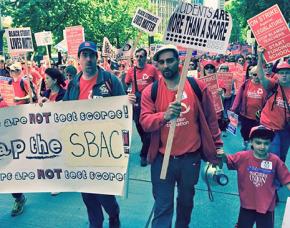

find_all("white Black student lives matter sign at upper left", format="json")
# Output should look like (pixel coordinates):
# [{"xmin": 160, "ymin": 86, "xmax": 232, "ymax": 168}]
[{"xmin": 5, "ymin": 28, "xmax": 34, "ymax": 53}]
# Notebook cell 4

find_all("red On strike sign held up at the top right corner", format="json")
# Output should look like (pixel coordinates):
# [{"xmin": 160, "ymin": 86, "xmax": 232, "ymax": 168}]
[{"xmin": 248, "ymin": 4, "xmax": 290, "ymax": 63}]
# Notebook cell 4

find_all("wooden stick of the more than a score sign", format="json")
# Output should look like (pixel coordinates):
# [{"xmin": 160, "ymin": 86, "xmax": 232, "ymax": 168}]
[{"xmin": 160, "ymin": 48, "xmax": 193, "ymax": 180}]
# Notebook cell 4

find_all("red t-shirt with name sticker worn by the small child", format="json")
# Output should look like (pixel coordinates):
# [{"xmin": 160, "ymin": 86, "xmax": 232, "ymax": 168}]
[{"xmin": 227, "ymin": 150, "xmax": 290, "ymax": 213}]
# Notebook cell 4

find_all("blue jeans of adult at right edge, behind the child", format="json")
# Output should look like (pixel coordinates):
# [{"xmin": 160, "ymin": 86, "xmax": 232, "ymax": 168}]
[{"xmin": 269, "ymin": 126, "xmax": 290, "ymax": 162}]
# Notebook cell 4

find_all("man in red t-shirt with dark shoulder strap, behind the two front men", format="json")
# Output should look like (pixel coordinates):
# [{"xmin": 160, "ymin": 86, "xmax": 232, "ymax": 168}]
[{"xmin": 125, "ymin": 48, "xmax": 158, "ymax": 166}]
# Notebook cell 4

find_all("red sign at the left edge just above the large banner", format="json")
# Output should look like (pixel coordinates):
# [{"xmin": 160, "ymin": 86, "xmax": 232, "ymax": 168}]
[{"xmin": 0, "ymin": 76, "xmax": 15, "ymax": 106}]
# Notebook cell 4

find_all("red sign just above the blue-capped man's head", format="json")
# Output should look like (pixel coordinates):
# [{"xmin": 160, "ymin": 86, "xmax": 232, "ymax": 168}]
[{"xmin": 65, "ymin": 25, "xmax": 85, "ymax": 58}]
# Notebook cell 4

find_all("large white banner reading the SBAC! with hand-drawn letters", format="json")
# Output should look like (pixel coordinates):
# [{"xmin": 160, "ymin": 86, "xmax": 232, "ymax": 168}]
[{"xmin": 0, "ymin": 96, "xmax": 132, "ymax": 195}]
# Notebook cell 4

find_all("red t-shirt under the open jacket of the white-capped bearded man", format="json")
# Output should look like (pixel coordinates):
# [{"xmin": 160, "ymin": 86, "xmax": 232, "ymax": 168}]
[{"xmin": 156, "ymin": 80, "xmax": 201, "ymax": 155}]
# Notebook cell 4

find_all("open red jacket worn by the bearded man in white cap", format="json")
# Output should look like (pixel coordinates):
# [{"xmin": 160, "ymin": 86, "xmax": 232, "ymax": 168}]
[{"xmin": 140, "ymin": 78, "xmax": 223, "ymax": 164}]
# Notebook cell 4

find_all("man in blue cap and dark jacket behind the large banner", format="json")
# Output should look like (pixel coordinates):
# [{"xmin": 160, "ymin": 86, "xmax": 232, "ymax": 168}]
[{"xmin": 63, "ymin": 41, "xmax": 135, "ymax": 228}]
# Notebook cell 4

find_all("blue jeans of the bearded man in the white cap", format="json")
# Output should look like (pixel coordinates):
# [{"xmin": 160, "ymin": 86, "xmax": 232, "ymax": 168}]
[{"xmin": 151, "ymin": 152, "xmax": 200, "ymax": 228}]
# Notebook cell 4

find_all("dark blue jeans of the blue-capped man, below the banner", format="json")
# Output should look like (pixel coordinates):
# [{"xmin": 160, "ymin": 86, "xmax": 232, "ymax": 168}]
[{"xmin": 82, "ymin": 193, "xmax": 120, "ymax": 228}]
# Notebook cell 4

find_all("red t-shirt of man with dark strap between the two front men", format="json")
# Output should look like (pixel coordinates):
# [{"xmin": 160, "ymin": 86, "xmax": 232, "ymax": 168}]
[{"xmin": 125, "ymin": 64, "xmax": 159, "ymax": 93}]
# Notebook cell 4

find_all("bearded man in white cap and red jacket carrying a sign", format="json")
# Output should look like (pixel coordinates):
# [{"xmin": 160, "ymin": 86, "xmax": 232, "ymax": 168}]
[{"xmin": 140, "ymin": 45, "xmax": 223, "ymax": 228}]
